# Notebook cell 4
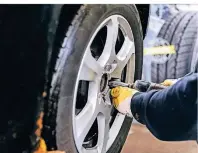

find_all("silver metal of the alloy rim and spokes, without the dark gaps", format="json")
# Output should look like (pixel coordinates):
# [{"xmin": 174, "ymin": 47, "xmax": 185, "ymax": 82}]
[{"xmin": 72, "ymin": 15, "xmax": 135, "ymax": 153}]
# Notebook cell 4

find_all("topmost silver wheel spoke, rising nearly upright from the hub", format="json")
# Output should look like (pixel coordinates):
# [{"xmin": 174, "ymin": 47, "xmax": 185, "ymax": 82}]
[{"xmin": 98, "ymin": 16, "xmax": 119, "ymax": 66}]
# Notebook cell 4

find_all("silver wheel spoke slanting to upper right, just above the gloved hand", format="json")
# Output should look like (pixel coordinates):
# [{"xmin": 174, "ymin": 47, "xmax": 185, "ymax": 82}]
[{"xmin": 111, "ymin": 37, "xmax": 135, "ymax": 78}]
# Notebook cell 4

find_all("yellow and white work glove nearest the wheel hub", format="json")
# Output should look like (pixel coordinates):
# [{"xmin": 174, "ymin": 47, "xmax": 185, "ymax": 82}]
[{"xmin": 111, "ymin": 86, "xmax": 138, "ymax": 117}]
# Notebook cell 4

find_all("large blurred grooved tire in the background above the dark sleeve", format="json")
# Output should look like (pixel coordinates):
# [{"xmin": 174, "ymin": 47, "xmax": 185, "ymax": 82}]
[{"xmin": 151, "ymin": 12, "xmax": 197, "ymax": 83}]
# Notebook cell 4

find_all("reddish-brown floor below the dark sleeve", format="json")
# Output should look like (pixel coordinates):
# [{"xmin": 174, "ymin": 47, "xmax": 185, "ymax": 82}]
[{"xmin": 122, "ymin": 124, "xmax": 198, "ymax": 153}]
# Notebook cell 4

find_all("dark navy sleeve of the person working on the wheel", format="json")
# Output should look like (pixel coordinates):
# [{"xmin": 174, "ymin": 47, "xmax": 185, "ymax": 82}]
[{"xmin": 131, "ymin": 73, "xmax": 198, "ymax": 141}]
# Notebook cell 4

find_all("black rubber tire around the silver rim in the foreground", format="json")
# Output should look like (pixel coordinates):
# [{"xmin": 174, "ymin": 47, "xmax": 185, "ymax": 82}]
[{"xmin": 52, "ymin": 5, "xmax": 143, "ymax": 153}]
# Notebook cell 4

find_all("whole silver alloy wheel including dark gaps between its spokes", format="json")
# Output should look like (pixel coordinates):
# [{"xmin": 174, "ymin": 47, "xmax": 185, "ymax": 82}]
[{"xmin": 72, "ymin": 15, "xmax": 135, "ymax": 153}]
